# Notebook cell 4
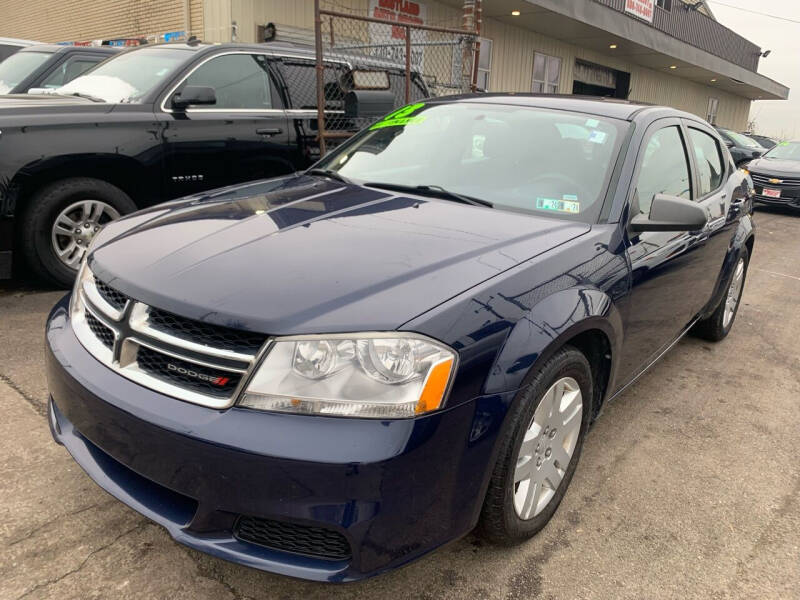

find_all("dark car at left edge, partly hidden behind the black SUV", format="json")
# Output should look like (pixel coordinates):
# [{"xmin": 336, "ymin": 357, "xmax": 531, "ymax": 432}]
[{"xmin": 0, "ymin": 44, "xmax": 121, "ymax": 94}]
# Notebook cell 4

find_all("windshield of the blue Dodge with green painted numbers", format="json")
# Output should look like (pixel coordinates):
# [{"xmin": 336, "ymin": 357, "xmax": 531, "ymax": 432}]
[{"xmin": 317, "ymin": 102, "xmax": 628, "ymax": 222}]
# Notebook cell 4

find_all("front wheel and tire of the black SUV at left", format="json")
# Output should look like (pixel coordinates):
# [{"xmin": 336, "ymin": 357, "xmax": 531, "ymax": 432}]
[{"xmin": 20, "ymin": 177, "xmax": 136, "ymax": 287}]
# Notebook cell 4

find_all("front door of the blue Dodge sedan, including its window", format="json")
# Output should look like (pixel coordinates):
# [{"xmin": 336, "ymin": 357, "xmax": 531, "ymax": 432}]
[{"xmin": 620, "ymin": 119, "xmax": 700, "ymax": 381}]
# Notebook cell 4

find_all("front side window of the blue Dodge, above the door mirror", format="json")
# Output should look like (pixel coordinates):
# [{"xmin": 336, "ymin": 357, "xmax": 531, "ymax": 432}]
[{"xmin": 636, "ymin": 126, "xmax": 692, "ymax": 214}]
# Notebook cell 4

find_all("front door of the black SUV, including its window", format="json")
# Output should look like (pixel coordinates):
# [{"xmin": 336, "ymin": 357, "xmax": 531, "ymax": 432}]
[{"xmin": 161, "ymin": 52, "xmax": 294, "ymax": 197}]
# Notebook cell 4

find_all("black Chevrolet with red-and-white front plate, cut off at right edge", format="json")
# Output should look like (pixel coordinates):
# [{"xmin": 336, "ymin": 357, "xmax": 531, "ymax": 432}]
[{"xmin": 747, "ymin": 141, "xmax": 800, "ymax": 208}]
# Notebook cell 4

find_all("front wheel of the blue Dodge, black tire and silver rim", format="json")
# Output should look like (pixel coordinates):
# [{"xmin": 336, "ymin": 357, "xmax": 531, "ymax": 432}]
[{"xmin": 478, "ymin": 346, "xmax": 593, "ymax": 544}]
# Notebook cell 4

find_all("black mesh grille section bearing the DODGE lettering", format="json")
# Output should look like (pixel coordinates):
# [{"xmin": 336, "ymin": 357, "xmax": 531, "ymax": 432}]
[{"xmin": 136, "ymin": 346, "xmax": 241, "ymax": 398}]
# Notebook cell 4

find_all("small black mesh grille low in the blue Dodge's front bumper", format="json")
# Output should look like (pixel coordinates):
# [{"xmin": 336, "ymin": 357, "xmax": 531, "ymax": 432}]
[{"xmin": 233, "ymin": 516, "xmax": 350, "ymax": 560}]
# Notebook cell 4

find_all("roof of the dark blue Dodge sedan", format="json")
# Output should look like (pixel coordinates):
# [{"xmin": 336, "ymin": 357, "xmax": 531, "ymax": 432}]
[{"xmin": 429, "ymin": 92, "xmax": 700, "ymax": 121}]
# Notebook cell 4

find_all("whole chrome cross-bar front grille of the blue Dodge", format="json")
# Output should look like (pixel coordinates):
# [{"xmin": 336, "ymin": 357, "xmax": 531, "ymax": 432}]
[{"xmin": 70, "ymin": 267, "xmax": 267, "ymax": 408}]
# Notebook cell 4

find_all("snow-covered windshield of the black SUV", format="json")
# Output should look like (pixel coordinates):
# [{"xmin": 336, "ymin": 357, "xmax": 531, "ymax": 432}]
[{"xmin": 56, "ymin": 48, "xmax": 191, "ymax": 103}]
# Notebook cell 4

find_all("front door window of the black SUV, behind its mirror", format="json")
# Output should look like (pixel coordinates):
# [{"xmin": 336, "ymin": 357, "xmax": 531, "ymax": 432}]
[{"xmin": 184, "ymin": 54, "xmax": 272, "ymax": 110}]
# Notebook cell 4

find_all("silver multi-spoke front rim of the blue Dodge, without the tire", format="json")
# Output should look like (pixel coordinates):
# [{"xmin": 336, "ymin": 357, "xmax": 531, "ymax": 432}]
[{"xmin": 514, "ymin": 377, "xmax": 583, "ymax": 520}]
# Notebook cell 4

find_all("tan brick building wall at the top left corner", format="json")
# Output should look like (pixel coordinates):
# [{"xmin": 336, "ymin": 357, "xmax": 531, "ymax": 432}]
[{"xmin": 0, "ymin": 0, "xmax": 203, "ymax": 42}]
